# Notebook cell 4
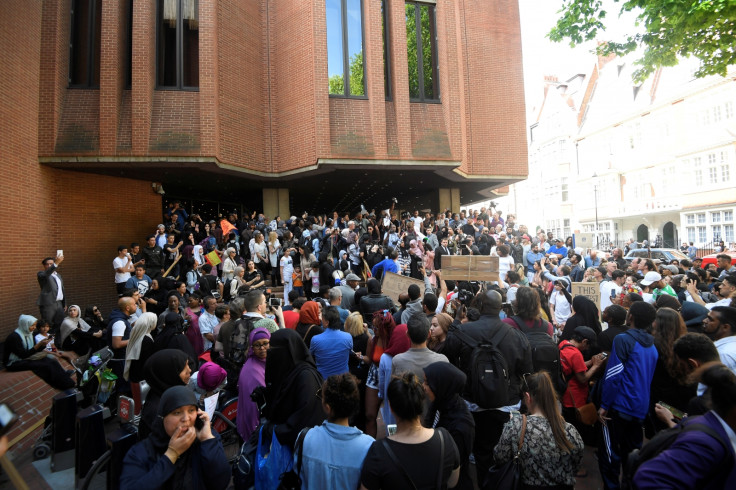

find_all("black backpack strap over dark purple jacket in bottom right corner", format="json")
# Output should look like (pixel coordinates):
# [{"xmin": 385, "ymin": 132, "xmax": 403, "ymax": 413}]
[{"xmin": 621, "ymin": 419, "xmax": 733, "ymax": 490}]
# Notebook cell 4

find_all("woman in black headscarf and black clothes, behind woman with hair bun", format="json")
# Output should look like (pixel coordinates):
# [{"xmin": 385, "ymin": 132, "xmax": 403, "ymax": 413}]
[{"xmin": 424, "ymin": 362, "xmax": 475, "ymax": 490}]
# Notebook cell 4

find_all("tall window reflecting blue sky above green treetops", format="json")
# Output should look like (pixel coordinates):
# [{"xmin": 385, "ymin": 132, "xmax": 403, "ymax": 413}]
[{"xmin": 326, "ymin": 0, "xmax": 365, "ymax": 97}]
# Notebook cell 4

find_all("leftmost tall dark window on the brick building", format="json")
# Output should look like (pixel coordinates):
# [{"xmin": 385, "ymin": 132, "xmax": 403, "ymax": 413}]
[{"xmin": 69, "ymin": 0, "xmax": 102, "ymax": 87}]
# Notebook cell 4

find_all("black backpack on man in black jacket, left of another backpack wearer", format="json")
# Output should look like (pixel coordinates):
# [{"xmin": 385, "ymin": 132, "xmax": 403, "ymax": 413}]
[{"xmin": 454, "ymin": 324, "xmax": 511, "ymax": 408}]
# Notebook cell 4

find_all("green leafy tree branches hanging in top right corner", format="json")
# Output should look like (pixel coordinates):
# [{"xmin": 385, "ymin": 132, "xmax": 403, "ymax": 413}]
[{"xmin": 549, "ymin": 0, "xmax": 736, "ymax": 82}]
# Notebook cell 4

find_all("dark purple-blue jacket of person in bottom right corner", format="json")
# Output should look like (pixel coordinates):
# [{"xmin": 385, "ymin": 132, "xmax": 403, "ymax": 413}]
[{"xmin": 634, "ymin": 412, "xmax": 736, "ymax": 490}]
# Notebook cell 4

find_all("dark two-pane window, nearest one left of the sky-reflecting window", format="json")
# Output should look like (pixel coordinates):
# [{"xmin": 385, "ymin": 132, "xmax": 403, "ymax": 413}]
[{"xmin": 156, "ymin": 0, "xmax": 199, "ymax": 89}]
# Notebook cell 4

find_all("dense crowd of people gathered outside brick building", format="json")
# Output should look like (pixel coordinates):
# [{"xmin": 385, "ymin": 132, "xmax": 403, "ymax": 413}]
[{"xmin": 5, "ymin": 202, "xmax": 736, "ymax": 489}]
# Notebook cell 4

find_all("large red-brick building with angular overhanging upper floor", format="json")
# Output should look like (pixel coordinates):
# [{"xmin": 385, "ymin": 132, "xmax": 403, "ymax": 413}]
[{"xmin": 0, "ymin": 0, "xmax": 527, "ymax": 337}]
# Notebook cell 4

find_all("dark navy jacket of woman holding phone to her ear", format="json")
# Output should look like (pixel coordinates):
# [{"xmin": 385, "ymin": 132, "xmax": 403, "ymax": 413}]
[{"xmin": 120, "ymin": 430, "xmax": 231, "ymax": 490}]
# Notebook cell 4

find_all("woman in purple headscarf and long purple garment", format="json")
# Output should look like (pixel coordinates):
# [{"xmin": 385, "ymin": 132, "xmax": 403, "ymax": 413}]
[{"xmin": 237, "ymin": 327, "xmax": 271, "ymax": 441}]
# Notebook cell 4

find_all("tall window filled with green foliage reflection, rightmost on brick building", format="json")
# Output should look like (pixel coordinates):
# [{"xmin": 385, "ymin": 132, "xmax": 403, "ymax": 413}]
[{"xmin": 405, "ymin": 2, "xmax": 440, "ymax": 100}]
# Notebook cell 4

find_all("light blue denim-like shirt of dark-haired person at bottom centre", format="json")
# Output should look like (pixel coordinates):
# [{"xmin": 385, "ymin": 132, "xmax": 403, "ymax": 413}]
[{"xmin": 294, "ymin": 420, "xmax": 373, "ymax": 490}]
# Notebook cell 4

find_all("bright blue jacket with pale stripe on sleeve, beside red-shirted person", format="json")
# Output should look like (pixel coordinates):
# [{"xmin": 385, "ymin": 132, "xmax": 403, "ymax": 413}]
[{"xmin": 601, "ymin": 328, "xmax": 659, "ymax": 420}]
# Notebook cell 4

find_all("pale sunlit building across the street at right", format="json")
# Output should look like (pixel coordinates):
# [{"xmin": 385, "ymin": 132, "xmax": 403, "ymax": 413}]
[{"xmin": 512, "ymin": 54, "xmax": 736, "ymax": 247}]
